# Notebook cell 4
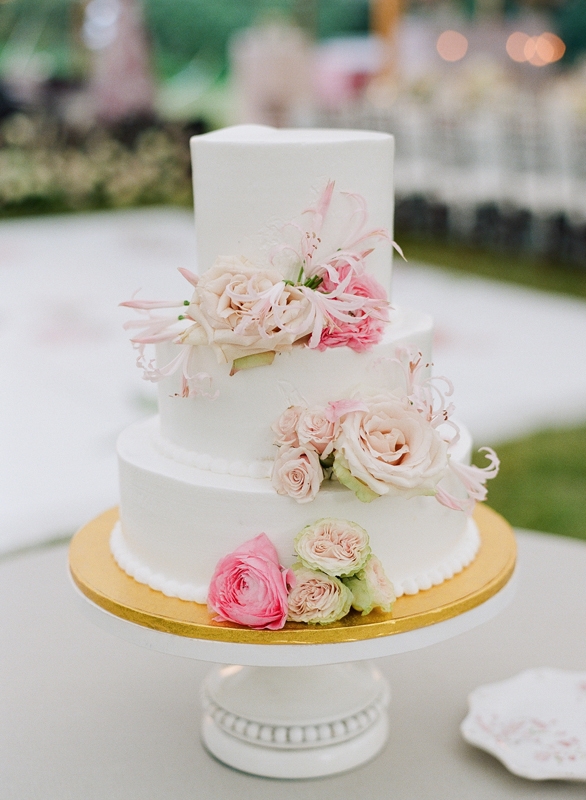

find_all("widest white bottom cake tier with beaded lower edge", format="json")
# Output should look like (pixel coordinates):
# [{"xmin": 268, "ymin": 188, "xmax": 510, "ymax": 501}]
[{"xmin": 111, "ymin": 417, "xmax": 480, "ymax": 603}]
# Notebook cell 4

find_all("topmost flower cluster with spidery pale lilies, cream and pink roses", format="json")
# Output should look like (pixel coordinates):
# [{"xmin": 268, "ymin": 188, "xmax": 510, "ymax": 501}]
[{"xmin": 121, "ymin": 181, "xmax": 402, "ymax": 396}]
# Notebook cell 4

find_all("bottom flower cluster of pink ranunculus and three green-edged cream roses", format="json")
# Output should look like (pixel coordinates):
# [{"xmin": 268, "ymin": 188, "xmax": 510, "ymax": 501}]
[{"xmin": 208, "ymin": 518, "xmax": 395, "ymax": 630}]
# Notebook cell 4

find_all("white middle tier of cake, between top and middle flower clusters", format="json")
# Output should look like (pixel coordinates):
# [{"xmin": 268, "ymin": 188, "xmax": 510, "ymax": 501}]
[{"xmin": 157, "ymin": 309, "xmax": 433, "ymax": 468}]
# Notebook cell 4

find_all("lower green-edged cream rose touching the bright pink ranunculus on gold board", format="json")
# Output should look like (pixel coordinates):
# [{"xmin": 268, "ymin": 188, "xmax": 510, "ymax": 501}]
[{"xmin": 287, "ymin": 564, "xmax": 352, "ymax": 625}]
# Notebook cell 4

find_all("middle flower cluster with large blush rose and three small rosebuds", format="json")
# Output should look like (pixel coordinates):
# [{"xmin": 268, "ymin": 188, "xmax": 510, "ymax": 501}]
[{"xmin": 272, "ymin": 348, "xmax": 499, "ymax": 514}]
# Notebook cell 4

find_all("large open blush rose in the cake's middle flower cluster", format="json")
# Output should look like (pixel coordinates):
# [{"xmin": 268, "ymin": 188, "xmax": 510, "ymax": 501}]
[{"xmin": 335, "ymin": 395, "xmax": 448, "ymax": 497}]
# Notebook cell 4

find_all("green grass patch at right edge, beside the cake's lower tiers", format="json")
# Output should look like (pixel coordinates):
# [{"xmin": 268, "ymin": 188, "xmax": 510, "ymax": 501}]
[{"xmin": 474, "ymin": 425, "xmax": 586, "ymax": 540}]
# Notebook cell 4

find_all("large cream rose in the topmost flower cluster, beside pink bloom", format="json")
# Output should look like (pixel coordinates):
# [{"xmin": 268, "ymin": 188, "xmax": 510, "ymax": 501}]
[{"xmin": 180, "ymin": 256, "xmax": 311, "ymax": 363}]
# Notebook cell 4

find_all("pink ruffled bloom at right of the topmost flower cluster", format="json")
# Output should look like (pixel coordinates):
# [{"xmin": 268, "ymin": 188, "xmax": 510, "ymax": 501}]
[{"xmin": 318, "ymin": 265, "xmax": 389, "ymax": 353}]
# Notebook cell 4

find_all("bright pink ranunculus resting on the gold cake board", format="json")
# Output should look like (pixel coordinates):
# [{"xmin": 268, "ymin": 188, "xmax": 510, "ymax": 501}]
[{"xmin": 208, "ymin": 533, "xmax": 294, "ymax": 631}]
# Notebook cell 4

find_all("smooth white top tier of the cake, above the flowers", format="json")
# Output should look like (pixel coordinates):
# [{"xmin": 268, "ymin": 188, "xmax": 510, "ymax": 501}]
[{"xmin": 191, "ymin": 125, "xmax": 394, "ymax": 293}]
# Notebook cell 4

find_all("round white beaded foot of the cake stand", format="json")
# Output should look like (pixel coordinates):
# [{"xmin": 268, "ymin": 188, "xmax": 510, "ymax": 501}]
[{"xmin": 202, "ymin": 663, "xmax": 389, "ymax": 778}]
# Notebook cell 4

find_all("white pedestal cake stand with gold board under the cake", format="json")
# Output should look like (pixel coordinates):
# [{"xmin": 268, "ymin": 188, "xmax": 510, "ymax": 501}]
[{"xmin": 70, "ymin": 506, "xmax": 516, "ymax": 778}]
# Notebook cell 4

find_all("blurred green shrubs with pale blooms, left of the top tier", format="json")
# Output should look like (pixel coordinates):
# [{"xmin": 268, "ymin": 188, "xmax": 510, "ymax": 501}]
[{"xmin": 0, "ymin": 113, "xmax": 194, "ymax": 217}]
